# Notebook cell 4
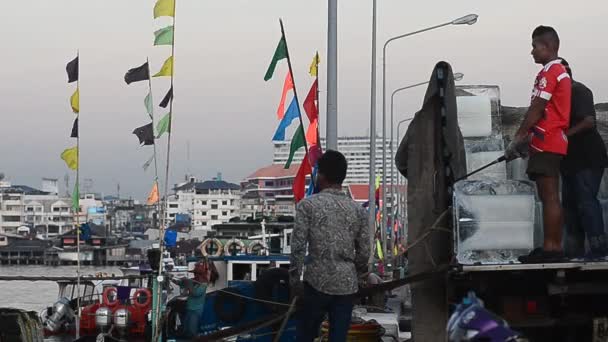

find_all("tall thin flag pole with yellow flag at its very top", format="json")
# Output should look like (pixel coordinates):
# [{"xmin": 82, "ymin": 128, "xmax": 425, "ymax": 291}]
[{"xmin": 153, "ymin": 0, "xmax": 177, "ymax": 341}]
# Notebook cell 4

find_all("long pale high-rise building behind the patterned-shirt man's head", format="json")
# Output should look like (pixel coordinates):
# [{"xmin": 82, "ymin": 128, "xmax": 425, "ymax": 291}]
[{"xmin": 272, "ymin": 136, "xmax": 398, "ymax": 185}]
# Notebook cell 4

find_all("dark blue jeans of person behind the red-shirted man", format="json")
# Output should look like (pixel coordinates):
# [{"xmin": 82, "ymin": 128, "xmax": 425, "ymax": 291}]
[{"xmin": 562, "ymin": 169, "xmax": 608, "ymax": 257}]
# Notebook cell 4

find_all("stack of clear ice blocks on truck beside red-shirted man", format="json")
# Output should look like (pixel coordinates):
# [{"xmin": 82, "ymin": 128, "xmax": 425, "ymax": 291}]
[{"xmin": 453, "ymin": 86, "xmax": 535, "ymax": 264}]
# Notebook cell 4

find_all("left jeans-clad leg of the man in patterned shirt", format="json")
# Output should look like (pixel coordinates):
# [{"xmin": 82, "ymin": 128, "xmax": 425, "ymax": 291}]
[{"xmin": 296, "ymin": 283, "xmax": 330, "ymax": 342}]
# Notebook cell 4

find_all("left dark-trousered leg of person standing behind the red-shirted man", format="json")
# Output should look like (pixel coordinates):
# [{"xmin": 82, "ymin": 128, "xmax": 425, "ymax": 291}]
[{"xmin": 562, "ymin": 174, "xmax": 585, "ymax": 258}]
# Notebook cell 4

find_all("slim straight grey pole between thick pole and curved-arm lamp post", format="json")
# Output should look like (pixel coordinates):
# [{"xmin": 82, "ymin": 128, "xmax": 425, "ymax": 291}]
[{"xmin": 368, "ymin": 0, "xmax": 377, "ymax": 258}]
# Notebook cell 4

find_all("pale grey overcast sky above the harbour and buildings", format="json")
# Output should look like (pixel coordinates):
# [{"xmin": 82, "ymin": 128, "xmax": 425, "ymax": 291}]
[{"xmin": 0, "ymin": 0, "xmax": 608, "ymax": 199}]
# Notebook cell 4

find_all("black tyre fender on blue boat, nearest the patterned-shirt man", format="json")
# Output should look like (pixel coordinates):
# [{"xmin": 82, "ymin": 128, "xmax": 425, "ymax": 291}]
[{"xmin": 254, "ymin": 268, "xmax": 290, "ymax": 313}]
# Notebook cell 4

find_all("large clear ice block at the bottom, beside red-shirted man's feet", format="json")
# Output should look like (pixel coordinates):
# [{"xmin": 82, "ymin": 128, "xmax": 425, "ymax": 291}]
[{"xmin": 454, "ymin": 180, "xmax": 536, "ymax": 264}]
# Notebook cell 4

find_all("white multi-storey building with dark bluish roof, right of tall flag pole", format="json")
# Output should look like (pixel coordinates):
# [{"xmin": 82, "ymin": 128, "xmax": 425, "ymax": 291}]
[{"xmin": 167, "ymin": 177, "xmax": 241, "ymax": 230}]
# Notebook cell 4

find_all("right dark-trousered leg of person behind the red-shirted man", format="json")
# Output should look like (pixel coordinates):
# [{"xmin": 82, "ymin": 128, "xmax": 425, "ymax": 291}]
[{"xmin": 576, "ymin": 169, "xmax": 607, "ymax": 256}]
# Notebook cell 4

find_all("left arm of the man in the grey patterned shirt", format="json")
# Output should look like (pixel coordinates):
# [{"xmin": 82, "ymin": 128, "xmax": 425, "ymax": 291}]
[{"xmin": 289, "ymin": 201, "xmax": 312, "ymax": 281}]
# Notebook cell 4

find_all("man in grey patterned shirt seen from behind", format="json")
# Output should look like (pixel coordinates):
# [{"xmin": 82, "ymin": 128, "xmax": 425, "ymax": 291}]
[{"xmin": 290, "ymin": 150, "xmax": 371, "ymax": 342}]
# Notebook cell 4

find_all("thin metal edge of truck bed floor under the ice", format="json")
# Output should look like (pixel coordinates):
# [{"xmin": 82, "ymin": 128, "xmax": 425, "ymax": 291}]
[{"xmin": 456, "ymin": 261, "xmax": 608, "ymax": 272}]
